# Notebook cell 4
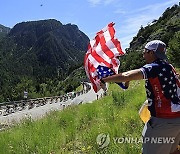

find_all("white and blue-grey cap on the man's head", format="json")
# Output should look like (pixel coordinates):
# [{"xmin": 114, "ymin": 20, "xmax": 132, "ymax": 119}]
[{"xmin": 145, "ymin": 40, "xmax": 167, "ymax": 59}]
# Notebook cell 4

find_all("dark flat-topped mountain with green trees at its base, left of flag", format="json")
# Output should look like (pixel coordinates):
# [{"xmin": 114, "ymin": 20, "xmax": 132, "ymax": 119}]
[{"xmin": 0, "ymin": 19, "xmax": 89, "ymax": 100}]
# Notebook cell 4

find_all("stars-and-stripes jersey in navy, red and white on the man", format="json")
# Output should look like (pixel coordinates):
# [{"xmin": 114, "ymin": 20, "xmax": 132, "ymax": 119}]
[{"xmin": 141, "ymin": 59, "xmax": 180, "ymax": 118}]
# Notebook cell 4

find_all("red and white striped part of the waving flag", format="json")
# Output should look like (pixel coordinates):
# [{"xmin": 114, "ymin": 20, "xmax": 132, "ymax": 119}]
[{"xmin": 84, "ymin": 23, "xmax": 124, "ymax": 92}]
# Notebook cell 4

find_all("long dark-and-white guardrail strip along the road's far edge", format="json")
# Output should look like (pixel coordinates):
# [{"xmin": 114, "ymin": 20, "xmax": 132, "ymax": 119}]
[{"xmin": 0, "ymin": 83, "xmax": 91, "ymax": 116}]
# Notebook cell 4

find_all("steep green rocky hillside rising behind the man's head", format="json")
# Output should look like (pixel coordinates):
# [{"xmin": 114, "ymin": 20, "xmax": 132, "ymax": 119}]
[{"xmin": 121, "ymin": 5, "xmax": 180, "ymax": 71}]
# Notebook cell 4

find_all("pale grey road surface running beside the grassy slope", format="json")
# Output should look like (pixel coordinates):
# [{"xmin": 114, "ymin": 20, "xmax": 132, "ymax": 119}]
[{"xmin": 0, "ymin": 83, "xmax": 103, "ymax": 125}]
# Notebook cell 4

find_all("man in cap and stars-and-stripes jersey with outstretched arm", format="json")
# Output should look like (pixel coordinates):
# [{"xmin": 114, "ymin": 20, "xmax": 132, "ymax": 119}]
[{"xmin": 101, "ymin": 40, "xmax": 180, "ymax": 154}]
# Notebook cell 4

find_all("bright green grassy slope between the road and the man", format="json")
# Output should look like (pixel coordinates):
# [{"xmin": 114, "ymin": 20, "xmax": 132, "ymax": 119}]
[{"xmin": 0, "ymin": 81, "xmax": 145, "ymax": 154}]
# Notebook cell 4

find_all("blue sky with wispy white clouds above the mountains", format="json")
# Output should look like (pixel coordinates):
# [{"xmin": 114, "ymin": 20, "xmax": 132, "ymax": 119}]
[{"xmin": 0, "ymin": 0, "xmax": 179, "ymax": 50}]
